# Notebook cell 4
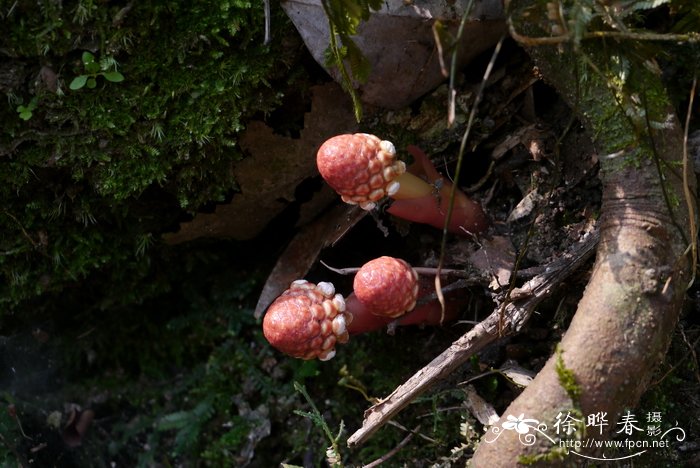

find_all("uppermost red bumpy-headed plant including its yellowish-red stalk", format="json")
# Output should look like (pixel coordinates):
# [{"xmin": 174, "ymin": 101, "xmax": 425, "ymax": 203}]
[{"xmin": 316, "ymin": 133, "xmax": 488, "ymax": 234}]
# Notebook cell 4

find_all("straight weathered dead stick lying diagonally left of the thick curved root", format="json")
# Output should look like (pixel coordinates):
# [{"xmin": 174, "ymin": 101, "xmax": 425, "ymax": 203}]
[{"xmin": 348, "ymin": 232, "xmax": 598, "ymax": 446}]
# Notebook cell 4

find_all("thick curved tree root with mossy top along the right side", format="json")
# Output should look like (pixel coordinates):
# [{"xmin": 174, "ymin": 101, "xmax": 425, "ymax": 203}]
[{"xmin": 472, "ymin": 1, "xmax": 695, "ymax": 467}]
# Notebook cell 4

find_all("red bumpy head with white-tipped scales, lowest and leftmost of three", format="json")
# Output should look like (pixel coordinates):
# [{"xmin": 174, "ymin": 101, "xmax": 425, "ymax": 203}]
[{"xmin": 263, "ymin": 280, "xmax": 352, "ymax": 361}]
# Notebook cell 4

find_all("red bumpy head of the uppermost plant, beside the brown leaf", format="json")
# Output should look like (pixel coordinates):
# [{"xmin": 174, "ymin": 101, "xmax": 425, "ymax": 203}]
[{"xmin": 316, "ymin": 133, "xmax": 406, "ymax": 210}]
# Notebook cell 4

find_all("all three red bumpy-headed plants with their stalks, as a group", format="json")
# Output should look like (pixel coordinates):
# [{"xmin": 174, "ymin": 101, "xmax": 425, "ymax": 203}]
[{"xmin": 263, "ymin": 133, "xmax": 488, "ymax": 361}]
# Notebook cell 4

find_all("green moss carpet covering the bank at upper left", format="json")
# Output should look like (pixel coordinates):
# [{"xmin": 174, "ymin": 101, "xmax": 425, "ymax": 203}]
[{"xmin": 0, "ymin": 0, "xmax": 290, "ymax": 319}]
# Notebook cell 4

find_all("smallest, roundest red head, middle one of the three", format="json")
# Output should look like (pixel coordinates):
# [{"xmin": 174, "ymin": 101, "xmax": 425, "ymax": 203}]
[{"xmin": 353, "ymin": 256, "xmax": 419, "ymax": 318}]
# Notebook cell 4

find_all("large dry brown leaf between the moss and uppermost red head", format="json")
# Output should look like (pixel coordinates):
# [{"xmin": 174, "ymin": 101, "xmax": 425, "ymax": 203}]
[{"xmin": 163, "ymin": 83, "xmax": 357, "ymax": 244}]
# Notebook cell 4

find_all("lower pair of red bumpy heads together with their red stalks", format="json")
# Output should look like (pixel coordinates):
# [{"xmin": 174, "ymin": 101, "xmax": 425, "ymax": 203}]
[{"xmin": 263, "ymin": 257, "xmax": 458, "ymax": 361}]
